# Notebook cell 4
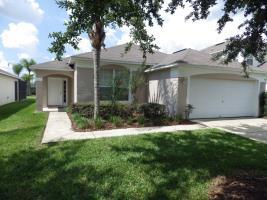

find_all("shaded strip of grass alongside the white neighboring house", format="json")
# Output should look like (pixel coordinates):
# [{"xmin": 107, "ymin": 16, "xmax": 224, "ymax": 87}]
[{"xmin": 0, "ymin": 98, "xmax": 35, "ymax": 121}]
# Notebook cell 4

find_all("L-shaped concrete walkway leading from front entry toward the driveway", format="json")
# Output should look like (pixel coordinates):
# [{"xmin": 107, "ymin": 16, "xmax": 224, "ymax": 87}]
[{"xmin": 42, "ymin": 112, "xmax": 204, "ymax": 144}]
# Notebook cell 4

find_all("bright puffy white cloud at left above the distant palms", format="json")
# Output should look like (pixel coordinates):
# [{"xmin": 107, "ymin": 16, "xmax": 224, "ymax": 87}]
[{"xmin": 0, "ymin": 22, "xmax": 39, "ymax": 52}]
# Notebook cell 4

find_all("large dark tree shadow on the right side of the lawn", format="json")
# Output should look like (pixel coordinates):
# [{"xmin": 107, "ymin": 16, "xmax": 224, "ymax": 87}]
[{"xmin": 112, "ymin": 130, "xmax": 267, "ymax": 199}]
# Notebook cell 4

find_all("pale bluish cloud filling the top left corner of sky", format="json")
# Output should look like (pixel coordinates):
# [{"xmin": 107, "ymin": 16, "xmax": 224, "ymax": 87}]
[{"xmin": 0, "ymin": 0, "xmax": 44, "ymax": 23}]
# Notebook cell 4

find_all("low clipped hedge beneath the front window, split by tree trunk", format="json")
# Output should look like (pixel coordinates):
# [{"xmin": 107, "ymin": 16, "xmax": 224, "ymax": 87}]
[{"xmin": 71, "ymin": 104, "xmax": 133, "ymax": 120}]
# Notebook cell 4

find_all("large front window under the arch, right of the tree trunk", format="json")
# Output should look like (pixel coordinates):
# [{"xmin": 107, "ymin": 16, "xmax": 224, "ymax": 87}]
[{"xmin": 99, "ymin": 69, "xmax": 130, "ymax": 101}]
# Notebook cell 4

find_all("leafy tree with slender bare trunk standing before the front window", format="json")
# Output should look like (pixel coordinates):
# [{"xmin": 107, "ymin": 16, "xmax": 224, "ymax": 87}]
[{"xmin": 49, "ymin": 0, "xmax": 164, "ymax": 119}]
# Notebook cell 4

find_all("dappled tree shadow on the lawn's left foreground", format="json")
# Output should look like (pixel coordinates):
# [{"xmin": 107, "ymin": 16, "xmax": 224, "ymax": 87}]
[{"xmin": 0, "ymin": 142, "xmax": 123, "ymax": 199}]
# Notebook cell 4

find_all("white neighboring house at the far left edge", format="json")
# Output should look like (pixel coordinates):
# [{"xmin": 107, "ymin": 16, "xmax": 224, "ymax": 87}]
[{"xmin": 0, "ymin": 69, "xmax": 26, "ymax": 105}]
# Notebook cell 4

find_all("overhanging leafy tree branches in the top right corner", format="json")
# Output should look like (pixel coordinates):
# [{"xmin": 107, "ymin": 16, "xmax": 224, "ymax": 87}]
[{"xmin": 167, "ymin": 0, "xmax": 267, "ymax": 75}]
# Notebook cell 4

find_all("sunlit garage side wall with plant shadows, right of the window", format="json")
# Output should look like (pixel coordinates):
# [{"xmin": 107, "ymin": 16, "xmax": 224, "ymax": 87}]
[{"xmin": 148, "ymin": 69, "xmax": 178, "ymax": 115}]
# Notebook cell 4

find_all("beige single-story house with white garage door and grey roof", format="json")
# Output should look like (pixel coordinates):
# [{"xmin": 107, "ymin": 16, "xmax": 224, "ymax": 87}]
[{"xmin": 32, "ymin": 45, "xmax": 267, "ymax": 118}]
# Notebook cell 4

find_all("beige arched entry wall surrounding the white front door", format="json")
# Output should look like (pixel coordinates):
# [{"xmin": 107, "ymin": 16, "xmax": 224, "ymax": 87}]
[{"xmin": 35, "ymin": 70, "xmax": 74, "ymax": 111}]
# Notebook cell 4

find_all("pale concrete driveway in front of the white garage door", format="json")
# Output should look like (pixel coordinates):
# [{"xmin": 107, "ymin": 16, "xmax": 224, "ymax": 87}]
[{"xmin": 195, "ymin": 118, "xmax": 267, "ymax": 143}]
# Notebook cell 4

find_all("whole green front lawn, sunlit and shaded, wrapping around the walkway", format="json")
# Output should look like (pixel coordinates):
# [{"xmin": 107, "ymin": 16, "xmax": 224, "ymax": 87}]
[{"xmin": 0, "ymin": 99, "xmax": 267, "ymax": 200}]
